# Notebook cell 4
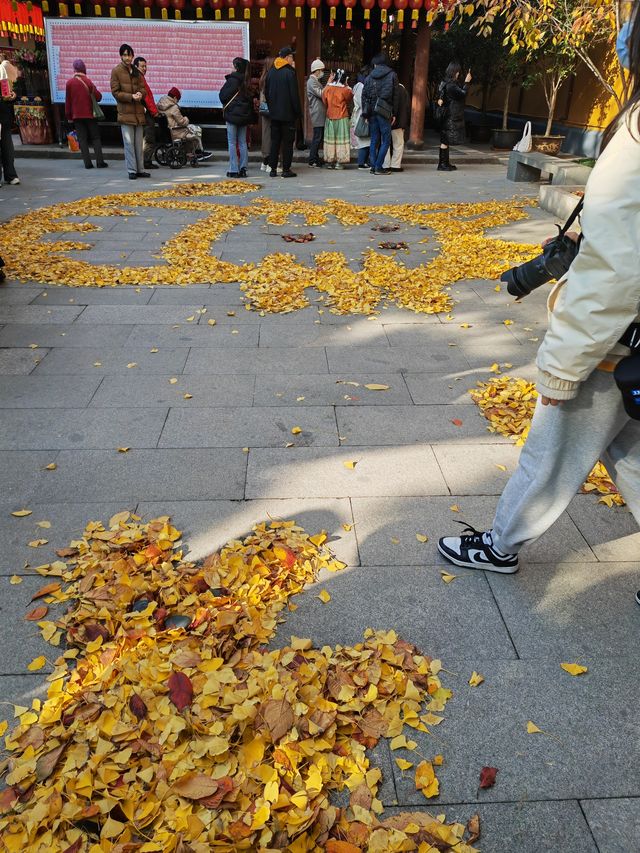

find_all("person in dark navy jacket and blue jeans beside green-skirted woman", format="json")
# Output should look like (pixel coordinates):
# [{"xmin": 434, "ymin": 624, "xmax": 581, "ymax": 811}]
[{"xmin": 362, "ymin": 53, "xmax": 399, "ymax": 175}]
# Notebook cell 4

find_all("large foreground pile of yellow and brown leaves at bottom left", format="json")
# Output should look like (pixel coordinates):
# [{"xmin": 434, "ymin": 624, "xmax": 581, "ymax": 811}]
[{"xmin": 0, "ymin": 512, "xmax": 477, "ymax": 853}]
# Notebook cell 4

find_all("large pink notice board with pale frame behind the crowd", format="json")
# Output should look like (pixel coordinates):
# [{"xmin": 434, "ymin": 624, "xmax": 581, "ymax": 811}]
[{"xmin": 45, "ymin": 18, "xmax": 249, "ymax": 107}]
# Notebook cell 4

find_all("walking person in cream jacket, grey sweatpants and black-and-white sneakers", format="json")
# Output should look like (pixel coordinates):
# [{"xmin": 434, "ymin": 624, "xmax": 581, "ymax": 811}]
[{"xmin": 438, "ymin": 15, "xmax": 640, "ymax": 574}]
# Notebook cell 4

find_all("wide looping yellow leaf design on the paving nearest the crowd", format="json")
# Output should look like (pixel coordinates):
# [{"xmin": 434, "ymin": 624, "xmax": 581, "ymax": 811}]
[{"xmin": 0, "ymin": 181, "xmax": 539, "ymax": 321}]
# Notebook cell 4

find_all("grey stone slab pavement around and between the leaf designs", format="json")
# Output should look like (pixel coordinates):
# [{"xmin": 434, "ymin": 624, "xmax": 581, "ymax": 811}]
[{"xmin": 0, "ymin": 160, "xmax": 640, "ymax": 853}]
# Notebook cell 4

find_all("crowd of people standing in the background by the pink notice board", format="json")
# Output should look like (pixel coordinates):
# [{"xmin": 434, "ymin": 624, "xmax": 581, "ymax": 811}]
[{"xmin": 57, "ymin": 44, "xmax": 471, "ymax": 180}]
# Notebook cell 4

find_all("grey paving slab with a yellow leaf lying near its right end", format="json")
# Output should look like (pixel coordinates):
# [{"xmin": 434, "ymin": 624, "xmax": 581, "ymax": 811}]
[{"xmin": 254, "ymin": 373, "xmax": 411, "ymax": 406}]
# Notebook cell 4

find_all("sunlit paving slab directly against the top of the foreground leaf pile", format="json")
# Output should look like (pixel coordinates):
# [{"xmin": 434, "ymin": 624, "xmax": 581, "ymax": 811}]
[{"xmin": 138, "ymin": 498, "xmax": 359, "ymax": 566}]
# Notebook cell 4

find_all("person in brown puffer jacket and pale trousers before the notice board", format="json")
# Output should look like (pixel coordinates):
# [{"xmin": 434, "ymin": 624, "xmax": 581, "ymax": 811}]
[{"xmin": 111, "ymin": 44, "xmax": 150, "ymax": 181}]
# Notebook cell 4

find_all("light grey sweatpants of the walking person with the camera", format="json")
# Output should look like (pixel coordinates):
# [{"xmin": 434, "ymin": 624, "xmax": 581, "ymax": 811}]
[{"xmin": 493, "ymin": 370, "xmax": 640, "ymax": 554}]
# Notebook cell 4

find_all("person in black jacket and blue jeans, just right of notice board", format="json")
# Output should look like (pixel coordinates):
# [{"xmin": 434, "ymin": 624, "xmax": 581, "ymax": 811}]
[{"xmin": 220, "ymin": 56, "xmax": 256, "ymax": 178}]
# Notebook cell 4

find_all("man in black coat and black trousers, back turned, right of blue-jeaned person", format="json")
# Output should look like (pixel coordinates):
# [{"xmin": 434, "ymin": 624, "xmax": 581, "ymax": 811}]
[{"xmin": 264, "ymin": 47, "xmax": 302, "ymax": 178}]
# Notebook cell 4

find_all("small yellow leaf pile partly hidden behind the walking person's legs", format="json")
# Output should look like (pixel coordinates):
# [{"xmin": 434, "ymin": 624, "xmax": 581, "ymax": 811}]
[{"xmin": 469, "ymin": 376, "xmax": 625, "ymax": 506}]
